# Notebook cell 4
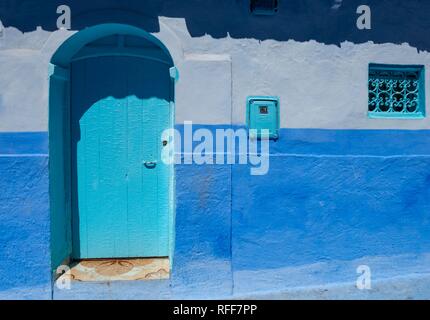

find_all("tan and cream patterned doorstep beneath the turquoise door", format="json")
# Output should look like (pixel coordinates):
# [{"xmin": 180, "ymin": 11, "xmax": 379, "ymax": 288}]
[{"xmin": 57, "ymin": 258, "xmax": 170, "ymax": 282}]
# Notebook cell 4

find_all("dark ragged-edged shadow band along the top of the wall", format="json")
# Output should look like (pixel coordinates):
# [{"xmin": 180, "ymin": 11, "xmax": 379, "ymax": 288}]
[{"xmin": 0, "ymin": 0, "xmax": 430, "ymax": 51}]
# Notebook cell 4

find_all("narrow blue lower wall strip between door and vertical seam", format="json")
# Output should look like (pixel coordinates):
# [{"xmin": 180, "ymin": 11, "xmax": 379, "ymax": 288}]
[{"xmin": 172, "ymin": 165, "xmax": 232, "ymax": 299}]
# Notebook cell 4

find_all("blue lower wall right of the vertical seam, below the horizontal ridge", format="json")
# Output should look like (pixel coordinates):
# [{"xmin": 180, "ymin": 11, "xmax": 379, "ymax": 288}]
[{"xmin": 232, "ymin": 155, "xmax": 430, "ymax": 294}]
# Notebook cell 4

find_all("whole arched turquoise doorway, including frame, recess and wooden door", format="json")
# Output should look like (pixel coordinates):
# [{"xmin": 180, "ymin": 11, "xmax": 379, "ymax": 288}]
[{"xmin": 49, "ymin": 24, "xmax": 174, "ymax": 268}]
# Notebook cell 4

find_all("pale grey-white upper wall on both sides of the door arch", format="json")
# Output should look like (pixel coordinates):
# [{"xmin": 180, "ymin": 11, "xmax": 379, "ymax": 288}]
[{"xmin": 0, "ymin": 17, "xmax": 430, "ymax": 132}]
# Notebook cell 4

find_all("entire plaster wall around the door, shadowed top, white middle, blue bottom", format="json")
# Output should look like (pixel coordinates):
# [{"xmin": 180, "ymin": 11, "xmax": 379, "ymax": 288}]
[{"xmin": 0, "ymin": 0, "xmax": 430, "ymax": 298}]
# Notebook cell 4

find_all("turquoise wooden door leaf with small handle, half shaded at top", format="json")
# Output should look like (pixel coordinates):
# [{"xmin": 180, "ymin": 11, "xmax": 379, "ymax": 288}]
[{"xmin": 71, "ymin": 56, "xmax": 172, "ymax": 259}]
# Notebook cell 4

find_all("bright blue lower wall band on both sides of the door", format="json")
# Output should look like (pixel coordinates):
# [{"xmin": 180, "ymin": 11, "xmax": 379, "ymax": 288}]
[{"xmin": 0, "ymin": 126, "xmax": 430, "ymax": 299}]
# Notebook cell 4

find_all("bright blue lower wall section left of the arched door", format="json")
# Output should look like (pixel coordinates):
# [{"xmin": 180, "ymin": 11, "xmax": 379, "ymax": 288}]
[{"xmin": 0, "ymin": 133, "xmax": 52, "ymax": 299}]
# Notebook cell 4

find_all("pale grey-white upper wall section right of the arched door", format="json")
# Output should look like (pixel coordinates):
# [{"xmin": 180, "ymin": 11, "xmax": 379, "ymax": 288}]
[{"xmin": 173, "ymin": 31, "xmax": 430, "ymax": 129}]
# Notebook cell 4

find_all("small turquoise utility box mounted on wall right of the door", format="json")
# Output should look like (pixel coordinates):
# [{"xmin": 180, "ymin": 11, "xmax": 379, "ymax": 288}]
[{"xmin": 246, "ymin": 97, "xmax": 280, "ymax": 140}]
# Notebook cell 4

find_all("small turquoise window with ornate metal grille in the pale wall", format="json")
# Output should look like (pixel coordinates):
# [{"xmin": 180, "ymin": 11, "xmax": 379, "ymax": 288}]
[{"xmin": 369, "ymin": 64, "xmax": 425, "ymax": 119}]
